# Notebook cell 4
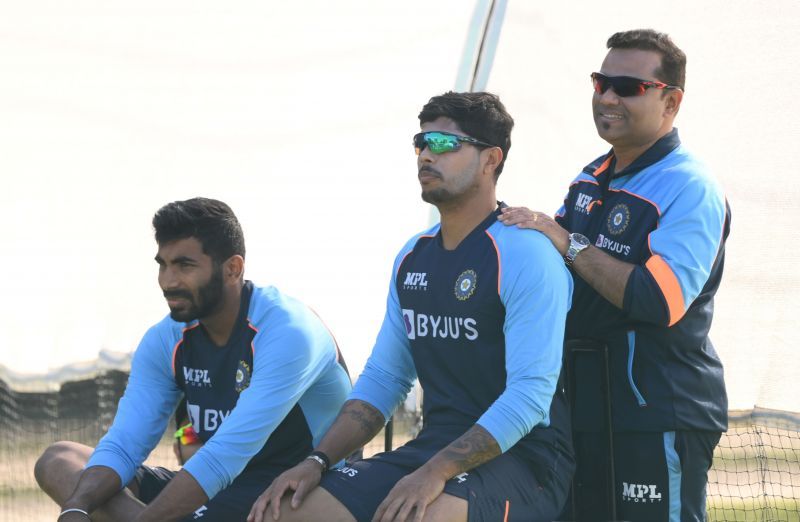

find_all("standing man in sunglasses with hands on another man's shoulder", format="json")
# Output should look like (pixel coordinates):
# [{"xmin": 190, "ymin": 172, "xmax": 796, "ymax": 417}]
[{"xmin": 500, "ymin": 30, "xmax": 730, "ymax": 522}]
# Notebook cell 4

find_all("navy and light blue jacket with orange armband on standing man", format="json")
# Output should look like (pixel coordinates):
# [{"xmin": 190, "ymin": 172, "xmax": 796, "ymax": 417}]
[{"xmin": 556, "ymin": 129, "xmax": 730, "ymax": 431}]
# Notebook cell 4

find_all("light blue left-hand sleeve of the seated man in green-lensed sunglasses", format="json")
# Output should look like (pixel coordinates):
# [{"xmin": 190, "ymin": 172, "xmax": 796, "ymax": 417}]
[{"xmin": 349, "ymin": 236, "xmax": 419, "ymax": 421}]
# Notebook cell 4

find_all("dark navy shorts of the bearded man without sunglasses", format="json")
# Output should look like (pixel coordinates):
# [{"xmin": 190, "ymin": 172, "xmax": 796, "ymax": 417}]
[{"xmin": 136, "ymin": 466, "xmax": 286, "ymax": 522}]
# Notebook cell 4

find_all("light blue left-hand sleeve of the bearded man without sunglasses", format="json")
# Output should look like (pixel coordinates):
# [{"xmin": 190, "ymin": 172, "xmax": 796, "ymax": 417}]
[{"xmin": 86, "ymin": 319, "xmax": 182, "ymax": 487}]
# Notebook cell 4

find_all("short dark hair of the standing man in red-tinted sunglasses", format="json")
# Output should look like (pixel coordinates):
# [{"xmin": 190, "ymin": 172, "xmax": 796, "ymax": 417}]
[{"xmin": 606, "ymin": 29, "xmax": 686, "ymax": 90}]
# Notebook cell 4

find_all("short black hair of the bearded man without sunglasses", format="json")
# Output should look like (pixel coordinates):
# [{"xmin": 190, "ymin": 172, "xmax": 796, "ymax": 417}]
[{"xmin": 153, "ymin": 198, "xmax": 245, "ymax": 264}]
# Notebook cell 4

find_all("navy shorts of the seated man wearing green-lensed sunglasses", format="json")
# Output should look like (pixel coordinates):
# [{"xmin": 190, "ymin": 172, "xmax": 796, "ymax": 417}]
[{"xmin": 320, "ymin": 431, "xmax": 570, "ymax": 522}]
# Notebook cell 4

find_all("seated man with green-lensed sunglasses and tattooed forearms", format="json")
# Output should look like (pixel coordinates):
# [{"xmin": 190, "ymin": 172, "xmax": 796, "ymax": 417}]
[{"xmin": 248, "ymin": 92, "xmax": 574, "ymax": 522}]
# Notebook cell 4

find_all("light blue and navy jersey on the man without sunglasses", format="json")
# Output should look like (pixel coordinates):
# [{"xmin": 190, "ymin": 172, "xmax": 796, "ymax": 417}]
[{"xmin": 87, "ymin": 281, "xmax": 351, "ymax": 498}]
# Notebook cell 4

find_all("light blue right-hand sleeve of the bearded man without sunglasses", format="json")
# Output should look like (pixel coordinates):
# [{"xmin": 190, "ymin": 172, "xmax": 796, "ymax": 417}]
[{"xmin": 184, "ymin": 309, "xmax": 344, "ymax": 498}]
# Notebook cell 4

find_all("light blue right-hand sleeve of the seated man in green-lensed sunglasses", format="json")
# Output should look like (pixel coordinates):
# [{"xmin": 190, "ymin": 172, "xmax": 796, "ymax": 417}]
[{"xmin": 478, "ymin": 224, "xmax": 572, "ymax": 451}]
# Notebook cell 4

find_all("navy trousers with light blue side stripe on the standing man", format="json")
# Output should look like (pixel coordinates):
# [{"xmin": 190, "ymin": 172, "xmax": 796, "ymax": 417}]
[{"xmin": 565, "ymin": 431, "xmax": 721, "ymax": 522}]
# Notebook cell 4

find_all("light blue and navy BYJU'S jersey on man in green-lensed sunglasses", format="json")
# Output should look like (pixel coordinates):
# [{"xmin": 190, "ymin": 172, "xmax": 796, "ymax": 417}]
[{"xmin": 351, "ymin": 206, "xmax": 572, "ymax": 467}]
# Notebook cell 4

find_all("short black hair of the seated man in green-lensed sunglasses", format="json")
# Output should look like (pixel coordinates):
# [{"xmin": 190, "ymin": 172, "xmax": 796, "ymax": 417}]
[{"xmin": 419, "ymin": 91, "xmax": 514, "ymax": 178}]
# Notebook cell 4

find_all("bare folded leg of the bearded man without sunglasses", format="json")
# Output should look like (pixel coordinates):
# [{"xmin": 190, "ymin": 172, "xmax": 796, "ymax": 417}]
[{"xmin": 33, "ymin": 441, "xmax": 144, "ymax": 522}]
